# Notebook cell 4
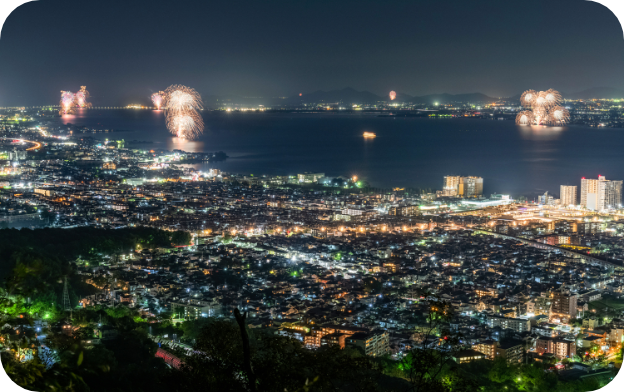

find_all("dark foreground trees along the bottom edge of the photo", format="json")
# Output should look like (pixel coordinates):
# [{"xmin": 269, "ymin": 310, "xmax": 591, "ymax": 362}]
[{"xmin": 0, "ymin": 306, "xmax": 600, "ymax": 392}]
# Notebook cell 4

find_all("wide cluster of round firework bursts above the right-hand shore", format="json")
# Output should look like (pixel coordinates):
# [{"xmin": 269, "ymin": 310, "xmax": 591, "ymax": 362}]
[{"xmin": 516, "ymin": 89, "xmax": 570, "ymax": 126}]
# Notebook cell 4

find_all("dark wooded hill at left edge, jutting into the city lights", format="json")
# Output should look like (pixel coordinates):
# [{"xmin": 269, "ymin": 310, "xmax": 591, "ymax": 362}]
[{"xmin": 0, "ymin": 227, "xmax": 191, "ymax": 312}]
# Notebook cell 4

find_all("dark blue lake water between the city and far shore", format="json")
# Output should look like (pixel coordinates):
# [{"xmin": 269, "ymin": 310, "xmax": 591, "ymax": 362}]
[{"xmin": 46, "ymin": 110, "xmax": 624, "ymax": 197}]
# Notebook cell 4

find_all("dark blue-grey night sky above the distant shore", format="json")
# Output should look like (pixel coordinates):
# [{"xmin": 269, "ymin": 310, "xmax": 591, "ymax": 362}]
[{"xmin": 0, "ymin": 0, "xmax": 624, "ymax": 105}]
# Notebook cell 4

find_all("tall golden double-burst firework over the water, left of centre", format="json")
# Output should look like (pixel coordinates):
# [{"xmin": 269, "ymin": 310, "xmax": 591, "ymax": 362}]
[{"xmin": 164, "ymin": 84, "xmax": 204, "ymax": 139}]
